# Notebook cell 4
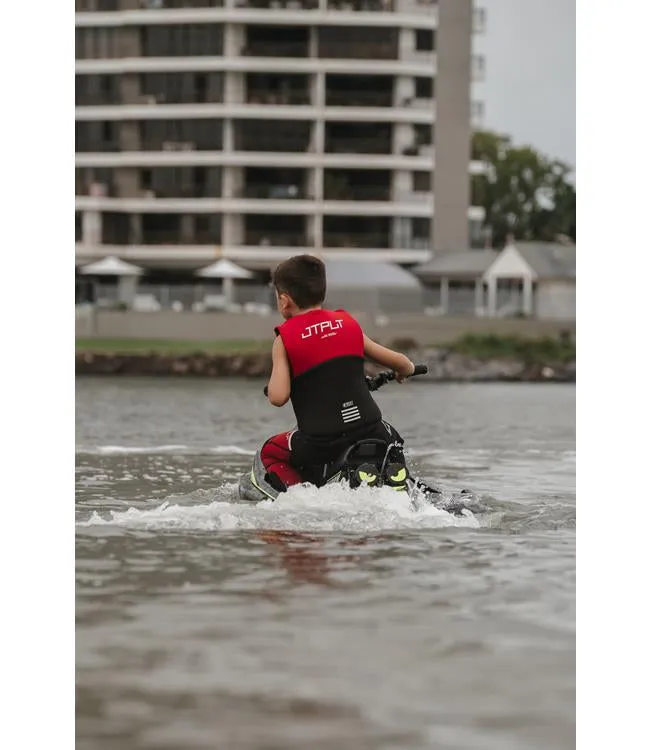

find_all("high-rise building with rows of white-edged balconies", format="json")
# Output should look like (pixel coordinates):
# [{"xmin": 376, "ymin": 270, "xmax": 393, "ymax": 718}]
[{"xmin": 75, "ymin": 0, "xmax": 482, "ymax": 268}]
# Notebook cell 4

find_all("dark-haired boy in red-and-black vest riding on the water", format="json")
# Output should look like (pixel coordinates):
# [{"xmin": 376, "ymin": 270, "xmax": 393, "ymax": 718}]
[{"xmin": 261, "ymin": 255, "xmax": 414, "ymax": 492}]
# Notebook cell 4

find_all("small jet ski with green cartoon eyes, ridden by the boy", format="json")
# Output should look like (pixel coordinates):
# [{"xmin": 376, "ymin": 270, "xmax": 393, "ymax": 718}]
[{"xmin": 239, "ymin": 364, "xmax": 471, "ymax": 514}]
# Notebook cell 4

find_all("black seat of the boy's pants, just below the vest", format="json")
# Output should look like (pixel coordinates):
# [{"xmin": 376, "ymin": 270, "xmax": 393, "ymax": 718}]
[{"xmin": 290, "ymin": 420, "xmax": 404, "ymax": 469}]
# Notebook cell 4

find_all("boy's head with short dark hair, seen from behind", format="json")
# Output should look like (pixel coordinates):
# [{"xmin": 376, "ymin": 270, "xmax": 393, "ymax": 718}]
[{"xmin": 273, "ymin": 255, "xmax": 326, "ymax": 320}]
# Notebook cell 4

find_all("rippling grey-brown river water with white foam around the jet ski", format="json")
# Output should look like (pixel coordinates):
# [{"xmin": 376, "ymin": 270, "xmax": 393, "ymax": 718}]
[{"xmin": 76, "ymin": 378, "xmax": 576, "ymax": 750}]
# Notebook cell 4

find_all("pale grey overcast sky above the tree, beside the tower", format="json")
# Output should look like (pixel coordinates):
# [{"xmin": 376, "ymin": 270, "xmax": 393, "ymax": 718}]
[{"xmin": 473, "ymin": 0, "xmax": 576, "ymax": 167}]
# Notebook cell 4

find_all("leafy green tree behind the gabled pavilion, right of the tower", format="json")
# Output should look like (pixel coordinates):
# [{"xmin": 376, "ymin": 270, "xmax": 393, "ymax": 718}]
[{"xmin": 472, "ymin": 131, "xmax": 576, "ymax": 247}]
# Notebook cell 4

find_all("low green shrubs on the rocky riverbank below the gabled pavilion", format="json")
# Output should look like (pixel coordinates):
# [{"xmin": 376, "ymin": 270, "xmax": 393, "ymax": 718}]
[{"xmin": 449, "ymin": 334, "xmax": 576, "ymax": 364}]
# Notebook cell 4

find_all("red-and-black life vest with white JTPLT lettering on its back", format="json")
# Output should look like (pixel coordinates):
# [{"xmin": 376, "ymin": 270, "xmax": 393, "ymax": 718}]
[{"xmin": 275, "ymin": 310, "xmax": 381, "ymax": 435}]
